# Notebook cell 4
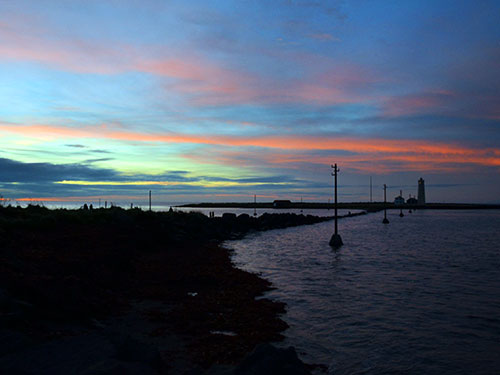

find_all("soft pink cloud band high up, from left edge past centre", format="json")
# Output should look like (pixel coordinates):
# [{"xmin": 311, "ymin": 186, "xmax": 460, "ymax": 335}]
[{"xmin": 0, "ymin": 16, "xmax": 378, "ymax": 106}]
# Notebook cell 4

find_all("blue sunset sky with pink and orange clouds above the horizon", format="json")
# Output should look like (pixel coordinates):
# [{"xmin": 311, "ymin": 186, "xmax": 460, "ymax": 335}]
[{"xmin": 0, "ymin": 0, "xmax": 500, "ymax": 204}]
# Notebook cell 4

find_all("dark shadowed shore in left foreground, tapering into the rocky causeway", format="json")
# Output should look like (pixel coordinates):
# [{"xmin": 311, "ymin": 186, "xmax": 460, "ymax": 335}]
[{"xmin": 0, "ymin": 205, "xmax": 365, "ymax": 374}]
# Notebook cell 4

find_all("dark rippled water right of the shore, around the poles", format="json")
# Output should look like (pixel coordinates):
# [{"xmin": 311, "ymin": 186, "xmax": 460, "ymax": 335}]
[{"xmin": 226, "ymin": 210, "xmax": 500, "ymax": 375}]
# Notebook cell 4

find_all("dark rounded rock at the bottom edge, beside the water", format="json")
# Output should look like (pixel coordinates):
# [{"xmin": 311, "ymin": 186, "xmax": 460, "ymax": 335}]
[{"xmin": 233, "ymin": 344, "xmax": 310, "ymax": 375}]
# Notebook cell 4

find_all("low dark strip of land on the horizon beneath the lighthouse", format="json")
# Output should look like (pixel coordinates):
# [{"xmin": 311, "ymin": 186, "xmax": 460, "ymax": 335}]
[{"xmin": 176, "ymin": 202, "xmax": 500, "ymax": 212}]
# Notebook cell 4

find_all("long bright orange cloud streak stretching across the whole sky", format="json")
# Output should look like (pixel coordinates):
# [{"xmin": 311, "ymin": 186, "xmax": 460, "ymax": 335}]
[{"xmin": 0, "ymin": 123, "xmax": 500, "ymax": 172}]
